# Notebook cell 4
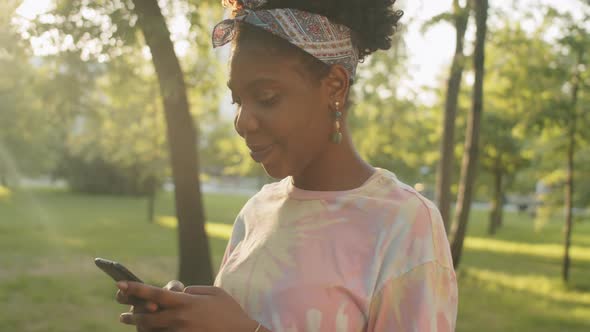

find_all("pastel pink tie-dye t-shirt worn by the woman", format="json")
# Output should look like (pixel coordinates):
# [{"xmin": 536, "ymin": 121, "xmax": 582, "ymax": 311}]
[{"xmin": 215, "ymin": 169, "xmax": 457, "ymax": 332}]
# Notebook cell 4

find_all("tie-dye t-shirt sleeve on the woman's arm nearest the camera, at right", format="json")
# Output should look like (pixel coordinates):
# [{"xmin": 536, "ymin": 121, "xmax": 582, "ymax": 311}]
[{"xmin": 367, "ymin": 261, "xmax": 458, "ymax": 332}]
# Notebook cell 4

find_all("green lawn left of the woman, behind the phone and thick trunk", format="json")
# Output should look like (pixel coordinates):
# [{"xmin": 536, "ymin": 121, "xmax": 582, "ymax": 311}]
[{"xmin": 0, "ymin": 191, "xmax": 247, "ymax": 332}]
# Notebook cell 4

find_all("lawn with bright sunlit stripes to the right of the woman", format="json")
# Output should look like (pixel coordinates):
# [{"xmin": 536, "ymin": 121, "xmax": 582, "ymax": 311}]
[{"xmin": 458, "ymin": 212, "xmax": 590, "ymax": 332}]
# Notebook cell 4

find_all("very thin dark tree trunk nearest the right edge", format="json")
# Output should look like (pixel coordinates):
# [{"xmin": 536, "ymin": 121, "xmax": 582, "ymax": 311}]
[{"xmin": 562, "ymin": 52, "xmax": 582, "ymax": 282}]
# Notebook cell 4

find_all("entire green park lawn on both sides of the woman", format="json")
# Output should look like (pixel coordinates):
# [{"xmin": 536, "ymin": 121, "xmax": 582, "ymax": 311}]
[{"xmin": 0, "ymin": 191, "xmax": 590, "ymax": 332}]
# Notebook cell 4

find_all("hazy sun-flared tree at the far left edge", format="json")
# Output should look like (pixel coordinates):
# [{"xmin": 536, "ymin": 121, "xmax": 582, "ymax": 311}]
[{"xmin": 0, "ymin": 1, "xmax": 57, "ymax": 186}]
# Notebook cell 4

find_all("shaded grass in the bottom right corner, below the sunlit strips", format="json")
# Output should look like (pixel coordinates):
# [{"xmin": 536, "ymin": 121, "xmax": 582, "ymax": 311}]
[{"xmin": 457, "ymin": 268, "xmax": 590, "ymax": 332}]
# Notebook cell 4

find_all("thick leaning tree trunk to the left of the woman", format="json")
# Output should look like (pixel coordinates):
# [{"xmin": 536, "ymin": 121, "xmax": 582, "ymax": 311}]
[{"xmin": 133, "ymin": 0, "xmax": 213, "ymax": 285}]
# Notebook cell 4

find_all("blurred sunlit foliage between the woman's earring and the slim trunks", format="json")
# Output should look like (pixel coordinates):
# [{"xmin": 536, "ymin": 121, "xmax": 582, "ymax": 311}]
[{"xmin": 349, "ymin": 30, "xmax": 439, "ymax": 188}]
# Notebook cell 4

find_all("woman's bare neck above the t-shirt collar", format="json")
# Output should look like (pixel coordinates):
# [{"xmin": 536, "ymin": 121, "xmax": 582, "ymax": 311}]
[{"xmin": 293, "ymin": 133, "xmax": 375, "ymax": 191}]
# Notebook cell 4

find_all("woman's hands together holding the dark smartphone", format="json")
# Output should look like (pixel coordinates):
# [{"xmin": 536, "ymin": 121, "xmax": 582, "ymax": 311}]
[{"xmin": 117, "ymin": 282, "xmax": 258, "ymax": 332}]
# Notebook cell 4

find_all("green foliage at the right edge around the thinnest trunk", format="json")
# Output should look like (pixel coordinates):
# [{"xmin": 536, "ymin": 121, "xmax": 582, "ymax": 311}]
[{"xmin": 519, "ymin": 7, "xmax": 590, "ymax": 220}]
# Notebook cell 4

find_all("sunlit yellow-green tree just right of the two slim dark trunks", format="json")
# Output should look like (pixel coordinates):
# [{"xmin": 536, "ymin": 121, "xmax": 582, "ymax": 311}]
[{"xmin": 480, "ymin": 19, "xmax": 546, "ymax": 235}]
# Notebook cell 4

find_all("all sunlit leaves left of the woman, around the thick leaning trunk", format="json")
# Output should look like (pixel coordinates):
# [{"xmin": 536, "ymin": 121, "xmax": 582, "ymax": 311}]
[{"xmin": 5, "ymin": 0, "xmax": 222, "ymax": 192}]
